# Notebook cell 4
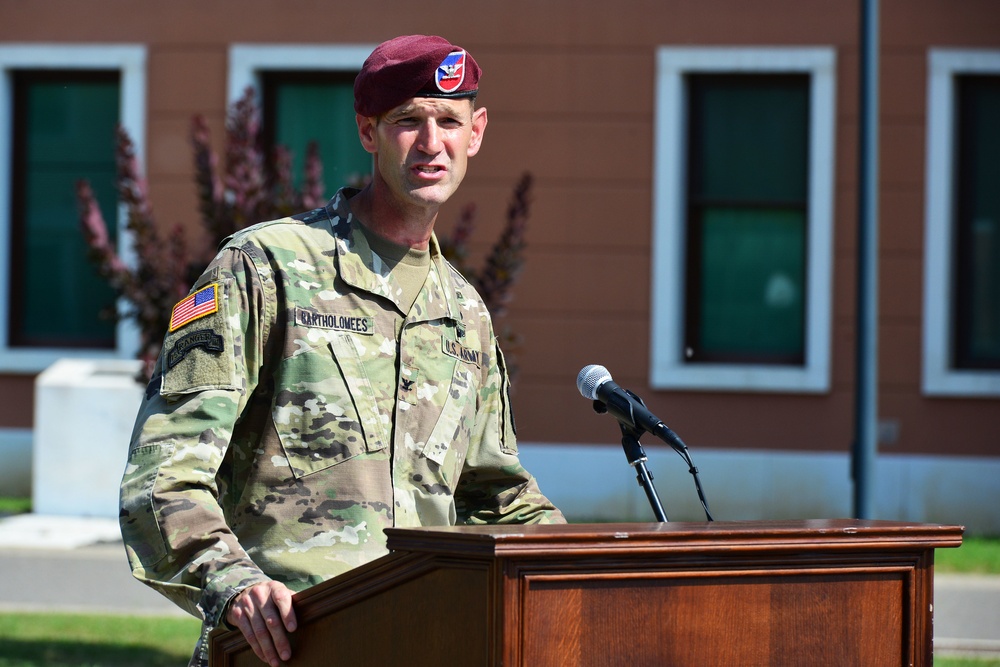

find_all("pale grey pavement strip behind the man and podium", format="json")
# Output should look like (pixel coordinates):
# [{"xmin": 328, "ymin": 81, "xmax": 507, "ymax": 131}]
[{"xmin": 0, "ymin": 514, "xmax": 1000, "ymax": 658}]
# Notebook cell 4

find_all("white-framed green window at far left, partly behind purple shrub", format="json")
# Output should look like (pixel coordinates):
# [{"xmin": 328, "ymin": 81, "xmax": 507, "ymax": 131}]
[{"xmin": 0, "ymin": 45, "xmax": 145, "ymax": 372}]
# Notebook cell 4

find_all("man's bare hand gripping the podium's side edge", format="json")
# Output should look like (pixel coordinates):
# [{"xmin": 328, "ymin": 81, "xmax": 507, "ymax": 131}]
[{"xmin": 226, "ymin": 581, "xmax": 296, "ymax": 667}]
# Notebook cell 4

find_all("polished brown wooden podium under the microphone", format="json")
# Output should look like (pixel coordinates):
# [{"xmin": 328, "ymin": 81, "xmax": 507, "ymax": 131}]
[{"xmin": 211, "ymin": 519, "xmax": 962, "ymax": 667}]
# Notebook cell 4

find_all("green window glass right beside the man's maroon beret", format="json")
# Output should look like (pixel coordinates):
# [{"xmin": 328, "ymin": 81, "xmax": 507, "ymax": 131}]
[{"xmin": 261, "ymin": 71, "xmax": 371, "ymax": 196}]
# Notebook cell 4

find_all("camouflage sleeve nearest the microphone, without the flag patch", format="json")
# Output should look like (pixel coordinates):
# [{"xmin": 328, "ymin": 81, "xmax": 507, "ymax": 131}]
[{"xmin": 455, "ymin": 340, "xmax": 566, "ymax": 525}]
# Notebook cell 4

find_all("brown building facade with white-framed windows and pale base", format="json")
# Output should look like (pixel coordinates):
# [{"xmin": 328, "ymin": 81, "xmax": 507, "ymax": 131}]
[{"xmin": 0, "ymin": 0, "xmax": 1000, "ymax": 532}]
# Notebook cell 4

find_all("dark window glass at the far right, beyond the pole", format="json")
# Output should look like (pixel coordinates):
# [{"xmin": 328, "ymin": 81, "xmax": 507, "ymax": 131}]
[{"xmin": 954, "ymin": 75, "xmax": 1000, "ymax": 369}]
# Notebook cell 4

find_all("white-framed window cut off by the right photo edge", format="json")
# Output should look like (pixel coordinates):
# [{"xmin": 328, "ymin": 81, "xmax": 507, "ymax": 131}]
[{"xmin": 923, "ymin": 49, "xmax": 1000, "ymax": 396}]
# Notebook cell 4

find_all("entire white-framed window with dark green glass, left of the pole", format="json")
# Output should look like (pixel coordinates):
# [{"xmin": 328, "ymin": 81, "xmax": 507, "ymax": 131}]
[{"xmin": 651, "ymin": 48, "xmax": 835, "ymax": 392}]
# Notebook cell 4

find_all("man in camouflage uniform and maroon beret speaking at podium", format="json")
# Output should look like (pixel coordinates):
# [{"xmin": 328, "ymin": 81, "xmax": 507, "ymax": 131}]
[{"xmin": 121, "ymin": 36, "xmax": 564, "ymax": 665}]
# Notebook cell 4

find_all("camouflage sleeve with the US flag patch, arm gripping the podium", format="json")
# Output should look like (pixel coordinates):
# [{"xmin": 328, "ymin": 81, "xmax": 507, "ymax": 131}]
[{"xmin": 119, "ymin": 249, "xmax": 274, "ymax": 625}]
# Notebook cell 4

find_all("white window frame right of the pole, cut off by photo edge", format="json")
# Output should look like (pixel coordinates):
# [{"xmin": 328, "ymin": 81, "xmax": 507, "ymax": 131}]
[{"xmin": 923, "ymin": 49, "xmax": 1000, "ymax": 396}]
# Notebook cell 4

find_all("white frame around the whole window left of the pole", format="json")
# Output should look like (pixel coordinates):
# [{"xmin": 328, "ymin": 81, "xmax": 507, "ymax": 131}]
[{"xmin": 650, "ymin": 47, "xmax": 836, "ymax": 393}]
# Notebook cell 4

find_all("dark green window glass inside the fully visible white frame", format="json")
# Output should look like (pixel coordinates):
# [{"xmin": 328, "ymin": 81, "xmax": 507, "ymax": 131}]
[{"xmin": 685, "ymin": 74, "xmax": 809, "ymax": 364}]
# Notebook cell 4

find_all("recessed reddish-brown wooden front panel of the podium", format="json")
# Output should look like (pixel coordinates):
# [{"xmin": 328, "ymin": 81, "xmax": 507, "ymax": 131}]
[{"xmin": 522, "ymin": 572, "xmax": 910, "ymax": 667}]
